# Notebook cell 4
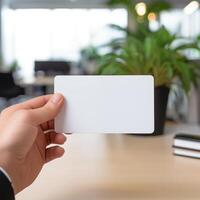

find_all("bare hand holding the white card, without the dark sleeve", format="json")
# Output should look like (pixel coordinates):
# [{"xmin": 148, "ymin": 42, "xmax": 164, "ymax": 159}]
[{"xmin": 0, "ymin": 94, "xmax": 66, "ymax": 194}]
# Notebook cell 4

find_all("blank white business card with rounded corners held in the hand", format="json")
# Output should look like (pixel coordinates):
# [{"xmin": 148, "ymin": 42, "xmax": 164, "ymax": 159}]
[{"xmin": 54, "ymin": 76, "xmax": 154, "ymax": 134}]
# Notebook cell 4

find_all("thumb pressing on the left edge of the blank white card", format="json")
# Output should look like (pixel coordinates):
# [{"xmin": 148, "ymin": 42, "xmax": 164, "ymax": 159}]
[{"xmin": 28, "ymin": 94, "xmax": 64, "ymax": 125}]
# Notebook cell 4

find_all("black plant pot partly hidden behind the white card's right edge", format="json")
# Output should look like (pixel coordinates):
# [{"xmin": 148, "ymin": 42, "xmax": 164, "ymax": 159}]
[{"xmin": 154, "ymin": 86, "xmax": 170, "ymax": 135}]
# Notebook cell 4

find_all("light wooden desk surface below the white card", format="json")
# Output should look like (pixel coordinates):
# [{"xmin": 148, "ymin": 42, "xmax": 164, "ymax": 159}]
[{"xmin": 17, "ymin": 124, "xmax": 200, "ymax": 200}]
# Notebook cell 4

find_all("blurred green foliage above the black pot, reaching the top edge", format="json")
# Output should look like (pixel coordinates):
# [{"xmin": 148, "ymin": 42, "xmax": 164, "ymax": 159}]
[{"xmin": 95, "ymin": 0, "xmax": 200, "ymax": 93}]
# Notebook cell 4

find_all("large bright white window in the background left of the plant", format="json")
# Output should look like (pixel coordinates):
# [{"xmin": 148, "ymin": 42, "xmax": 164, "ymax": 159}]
[{"xmin": 3, "ymin": 9, "xmax": 127, "ymax": 75}]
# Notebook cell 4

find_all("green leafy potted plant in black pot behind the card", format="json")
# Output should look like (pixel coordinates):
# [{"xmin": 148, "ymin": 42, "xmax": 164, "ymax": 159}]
[{"xmin": 98, "ymin": 27, "xmax": 198, "ymax": 134}]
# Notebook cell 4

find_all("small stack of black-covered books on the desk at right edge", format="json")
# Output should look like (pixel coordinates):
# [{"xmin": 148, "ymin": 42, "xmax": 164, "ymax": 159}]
[{"xmin": 173, "ymin": 134, "xmax": 200, "ymax": 159}]
